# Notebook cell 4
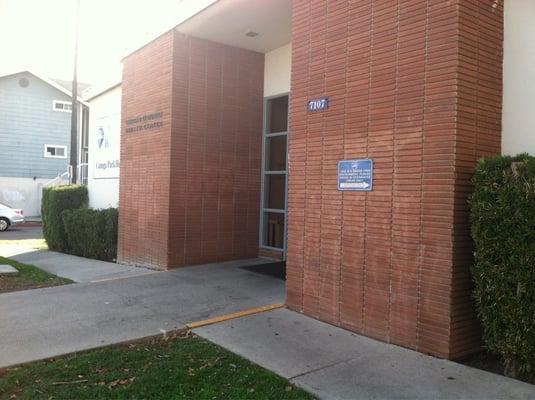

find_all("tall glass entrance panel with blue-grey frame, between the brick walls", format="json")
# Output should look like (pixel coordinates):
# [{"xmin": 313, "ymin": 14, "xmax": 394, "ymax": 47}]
[{"xmin": 260, "ymin": 95, "xmax": 288, "ymax": 259}]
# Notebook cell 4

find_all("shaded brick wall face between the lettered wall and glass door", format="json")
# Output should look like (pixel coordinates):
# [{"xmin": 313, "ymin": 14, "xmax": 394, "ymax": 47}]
[{"xmin": 169, "ymin": 34, "xmax": 264, "ymax": 266}]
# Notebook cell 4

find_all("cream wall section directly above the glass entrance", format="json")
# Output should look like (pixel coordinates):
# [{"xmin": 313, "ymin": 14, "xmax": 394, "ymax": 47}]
[{"xmin": 264, "ymin": 43, "xmax": 292, "ymax": 97}]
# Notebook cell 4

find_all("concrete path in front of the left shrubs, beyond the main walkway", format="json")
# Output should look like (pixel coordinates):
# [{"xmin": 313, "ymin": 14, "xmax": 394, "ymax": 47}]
[{"xmin": 11, "ymin": 250, "xmax": 159, "ymax": 282}]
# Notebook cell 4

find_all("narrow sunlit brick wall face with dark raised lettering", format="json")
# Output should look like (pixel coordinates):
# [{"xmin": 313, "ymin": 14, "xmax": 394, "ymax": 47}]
[{"xmin": 117, "ymin": 32, "xmax": 173, "ymax": 266}]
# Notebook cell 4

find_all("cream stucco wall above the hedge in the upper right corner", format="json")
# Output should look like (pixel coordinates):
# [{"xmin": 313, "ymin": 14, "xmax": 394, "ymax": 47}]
[{"xmin": 502, "ymin": 0, "xmax": 535, "ymax": 155}]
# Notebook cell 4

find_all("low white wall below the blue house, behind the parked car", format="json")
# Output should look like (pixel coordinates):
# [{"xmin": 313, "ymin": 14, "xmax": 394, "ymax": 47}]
[{"xmin": 0, "ymin": 176, "xmax": 50, "ymax": 217}]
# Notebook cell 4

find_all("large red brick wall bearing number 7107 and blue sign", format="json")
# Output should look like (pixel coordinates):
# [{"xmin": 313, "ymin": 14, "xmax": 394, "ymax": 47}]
[{"xmin": 287, "ymin": 0, "xmax": 503, "ymax": 358}]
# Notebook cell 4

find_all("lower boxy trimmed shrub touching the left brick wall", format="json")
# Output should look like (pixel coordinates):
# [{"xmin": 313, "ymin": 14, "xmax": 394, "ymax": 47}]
[{"xmin": 62, "ymin": 208, "xmax": 118, "ymax": 261}]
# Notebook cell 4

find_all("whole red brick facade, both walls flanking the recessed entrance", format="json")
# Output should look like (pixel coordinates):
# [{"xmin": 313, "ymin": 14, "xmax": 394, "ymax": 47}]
[{"xmin": 119, "ymin": 0, "xmax": 503, "ymax": 358}]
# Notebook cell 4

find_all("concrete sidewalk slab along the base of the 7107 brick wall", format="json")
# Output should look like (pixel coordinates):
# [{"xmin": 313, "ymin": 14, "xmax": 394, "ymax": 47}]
[{"xmin": 194, "ymin": 309, "xmax": 535, "ymax": 400}]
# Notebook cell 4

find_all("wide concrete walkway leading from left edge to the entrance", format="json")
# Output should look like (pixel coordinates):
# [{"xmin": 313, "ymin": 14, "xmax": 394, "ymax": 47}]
[{"xmin": 0, "ymin": 259, "xmax": 285, "ymax": 368}]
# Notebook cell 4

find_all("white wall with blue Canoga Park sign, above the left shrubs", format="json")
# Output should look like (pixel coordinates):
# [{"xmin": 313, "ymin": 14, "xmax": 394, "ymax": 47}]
[{"xmin": 88, "ymin": 86, "xmax": 121, "ymax": 208}]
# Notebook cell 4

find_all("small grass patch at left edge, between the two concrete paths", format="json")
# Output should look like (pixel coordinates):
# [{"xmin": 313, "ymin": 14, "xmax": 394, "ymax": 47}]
[{"xmin": 0, "ymin": 257, "xmax": 72, "ymax": 293}]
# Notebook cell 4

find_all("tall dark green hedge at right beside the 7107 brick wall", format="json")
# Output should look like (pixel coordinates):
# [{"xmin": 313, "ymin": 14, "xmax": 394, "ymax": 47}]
[{"xmin": 471, "ymin": 154, "xmax": 535, "ymax": 380}]
